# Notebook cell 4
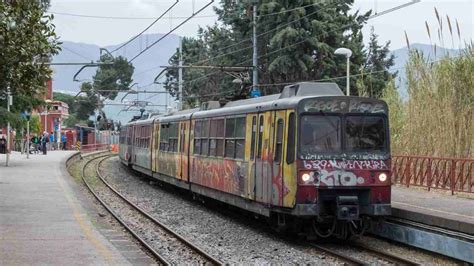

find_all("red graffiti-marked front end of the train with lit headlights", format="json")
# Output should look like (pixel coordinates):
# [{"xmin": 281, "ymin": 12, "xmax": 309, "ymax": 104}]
[{"xmin": 296, "ymin": 97, "xmax": 391, "ymax": 238}]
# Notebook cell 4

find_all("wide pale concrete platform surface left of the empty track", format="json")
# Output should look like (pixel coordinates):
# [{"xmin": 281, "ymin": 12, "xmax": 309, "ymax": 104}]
[{"xmin": 0, "ymin": 151, "xmax": 136, "ymax": 265}]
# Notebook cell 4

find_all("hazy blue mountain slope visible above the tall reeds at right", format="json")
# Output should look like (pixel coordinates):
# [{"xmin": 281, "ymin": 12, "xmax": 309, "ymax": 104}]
[{"xmin": 390, "ymin": 43, "xmax": 460, "ymax": 99}]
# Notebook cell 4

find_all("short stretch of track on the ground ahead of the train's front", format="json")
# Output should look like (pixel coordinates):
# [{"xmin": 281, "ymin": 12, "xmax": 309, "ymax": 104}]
[{"xmin": 310, "ymin": 242, "xmax": 420, "ymax": 265}]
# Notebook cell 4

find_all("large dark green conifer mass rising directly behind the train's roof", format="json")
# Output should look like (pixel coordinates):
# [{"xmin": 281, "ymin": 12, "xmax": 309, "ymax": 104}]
[{"xmin": 167, "ymin": 0, "xmax": 370, "ymax": 100}]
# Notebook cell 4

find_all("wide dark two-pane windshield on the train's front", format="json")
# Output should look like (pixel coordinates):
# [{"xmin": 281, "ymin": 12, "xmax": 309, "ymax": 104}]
[{"xmin": 299, "ymin": 112, "xmax": 388, "ymax": 158}]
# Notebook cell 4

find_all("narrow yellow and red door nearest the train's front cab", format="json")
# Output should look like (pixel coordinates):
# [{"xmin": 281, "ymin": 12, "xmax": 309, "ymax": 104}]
[{"xmin": 268, "ymin": 110, "xmax": 286, "ymax": 206}]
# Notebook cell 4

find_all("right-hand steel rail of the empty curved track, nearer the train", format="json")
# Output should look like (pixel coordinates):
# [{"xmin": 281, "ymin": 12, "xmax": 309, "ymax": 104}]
[{"xmin": 96, "ymin": 155, "xmax": 223, "ymax": 265}]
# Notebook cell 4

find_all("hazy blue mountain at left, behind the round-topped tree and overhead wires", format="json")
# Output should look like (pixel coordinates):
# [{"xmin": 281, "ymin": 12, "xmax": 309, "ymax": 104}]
[{"xmin": 52, "ymin": 34, "xmax": 179, "ymax": 123}]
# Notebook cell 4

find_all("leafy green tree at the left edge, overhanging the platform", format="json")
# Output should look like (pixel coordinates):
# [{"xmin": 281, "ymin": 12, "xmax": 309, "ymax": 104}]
[{"xmin": 0, "ymin": 1, "xmax": 60, "ymax": 125}]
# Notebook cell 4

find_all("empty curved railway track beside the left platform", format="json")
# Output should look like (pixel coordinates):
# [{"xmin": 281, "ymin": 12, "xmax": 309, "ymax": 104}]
[{"xmin": 81, "ymin": 154, "xmax": 223, "ymax": 265}]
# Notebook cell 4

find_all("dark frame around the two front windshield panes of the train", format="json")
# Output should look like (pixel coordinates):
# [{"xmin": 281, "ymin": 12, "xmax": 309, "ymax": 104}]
[{"xmin": 296, "ymin": 111, "xmax": 391, "ymax": 160}]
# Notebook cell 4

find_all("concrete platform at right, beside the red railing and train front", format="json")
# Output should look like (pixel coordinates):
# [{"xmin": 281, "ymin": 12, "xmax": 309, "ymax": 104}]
[{"xmin": 392, "ymin": 186, "xmax": 474, "ymax": 235}]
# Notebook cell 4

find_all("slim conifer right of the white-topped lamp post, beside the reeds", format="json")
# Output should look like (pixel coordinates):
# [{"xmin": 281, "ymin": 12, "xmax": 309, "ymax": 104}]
[{"xmin": 357, "ymin": 27, "xmax": 397, "ymax": 98}]
